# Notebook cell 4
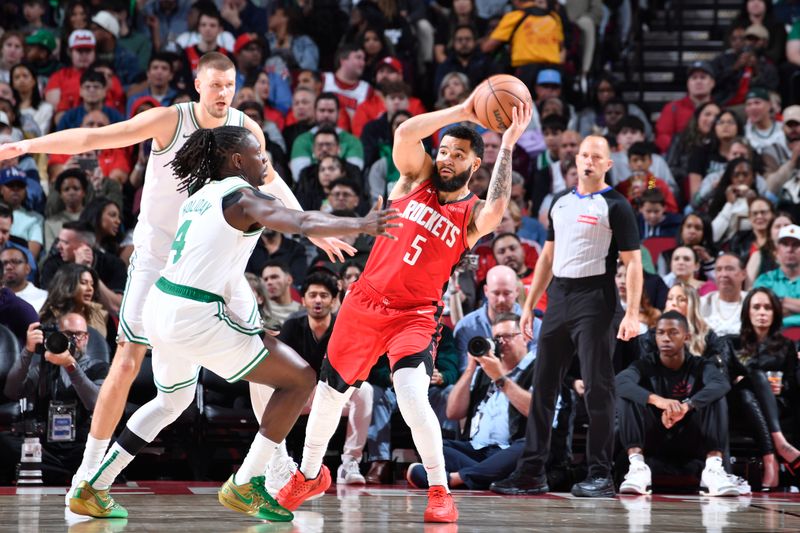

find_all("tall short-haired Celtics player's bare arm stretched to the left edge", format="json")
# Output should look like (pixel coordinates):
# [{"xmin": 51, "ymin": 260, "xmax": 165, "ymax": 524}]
[{"xmin": 0, "ymin": 107, "xmax": 177, "ymax": 160}]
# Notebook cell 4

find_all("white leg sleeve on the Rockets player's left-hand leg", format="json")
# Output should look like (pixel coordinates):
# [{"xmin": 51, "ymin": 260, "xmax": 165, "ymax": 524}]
[{"xmin": 300, "ymin": 381, "xmax": 355, "ymax": 479}]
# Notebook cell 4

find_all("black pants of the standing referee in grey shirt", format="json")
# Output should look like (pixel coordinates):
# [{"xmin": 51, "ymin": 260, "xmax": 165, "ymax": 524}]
[{"xmin": 517, "ymin": 276, "xmax": 619, "ymax": 477}]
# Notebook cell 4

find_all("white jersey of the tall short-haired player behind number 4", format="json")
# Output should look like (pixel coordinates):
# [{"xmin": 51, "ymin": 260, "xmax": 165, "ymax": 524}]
[{"xmin": 133, "ymin": 102, "xmax": 244, "ymax": 259}]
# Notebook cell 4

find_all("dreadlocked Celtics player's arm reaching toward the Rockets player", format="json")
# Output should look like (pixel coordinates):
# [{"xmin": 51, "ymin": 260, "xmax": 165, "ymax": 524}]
[{"xmin": 234, "ymin": 189, "xmax": 402, "ymax": 239}]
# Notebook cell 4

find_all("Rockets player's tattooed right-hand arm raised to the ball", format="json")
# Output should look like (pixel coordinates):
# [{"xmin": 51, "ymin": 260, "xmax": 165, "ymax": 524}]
[{"xmin": 467, "ymin": 104, "xmax": 532, "ymax": 247}]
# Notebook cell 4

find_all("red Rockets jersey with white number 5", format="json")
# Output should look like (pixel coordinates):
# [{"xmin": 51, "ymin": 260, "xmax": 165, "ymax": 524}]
[{"xmin": 359, "ymin": 180, "xmax": 478, "ymax": 306}]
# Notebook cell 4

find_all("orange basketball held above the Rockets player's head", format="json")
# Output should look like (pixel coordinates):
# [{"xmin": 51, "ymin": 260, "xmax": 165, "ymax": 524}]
[{"xmin": 475, "ymin": 74, "xmax": 533, "ymax": 133}]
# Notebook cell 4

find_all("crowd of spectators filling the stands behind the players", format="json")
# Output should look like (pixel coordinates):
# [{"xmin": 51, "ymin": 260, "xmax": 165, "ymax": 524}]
[{"xmin": 0, "ymin": 0, "xmax": 800, "ymax": 488}]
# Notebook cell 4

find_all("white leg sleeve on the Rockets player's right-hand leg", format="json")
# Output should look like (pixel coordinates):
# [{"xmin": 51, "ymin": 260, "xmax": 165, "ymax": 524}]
[{"xmin": 393, "ymin": 363, "xmax": 447, "ymax": 487}]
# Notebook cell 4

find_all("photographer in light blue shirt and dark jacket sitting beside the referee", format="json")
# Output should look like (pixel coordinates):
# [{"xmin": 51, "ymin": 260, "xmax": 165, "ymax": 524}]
[{"xmin": 406, "ymin": 313, "xmax": 536, "ymax": 490}]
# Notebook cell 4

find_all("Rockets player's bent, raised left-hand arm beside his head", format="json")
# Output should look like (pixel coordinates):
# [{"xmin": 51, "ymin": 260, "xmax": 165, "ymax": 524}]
[{"xmin": 392, "ymin": 88, "xmax": 478, "ymax": 178}]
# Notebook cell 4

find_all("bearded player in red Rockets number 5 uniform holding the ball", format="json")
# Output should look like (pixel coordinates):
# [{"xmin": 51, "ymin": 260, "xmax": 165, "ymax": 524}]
[{"xmin": 277, "ymin": 94, "xmax": 532, "ymax": 522}]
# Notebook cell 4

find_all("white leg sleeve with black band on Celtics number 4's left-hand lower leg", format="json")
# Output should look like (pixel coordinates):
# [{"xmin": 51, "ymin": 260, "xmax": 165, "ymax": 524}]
[{"xmin": 89, "ymin": 387, "xmax": 195, "ymax": 489}]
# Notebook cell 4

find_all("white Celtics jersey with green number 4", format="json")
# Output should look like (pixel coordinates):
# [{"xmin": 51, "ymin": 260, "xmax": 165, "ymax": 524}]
[{"xmin": 161, "ymin": 177, "xmax": 262, "ymax": 302}]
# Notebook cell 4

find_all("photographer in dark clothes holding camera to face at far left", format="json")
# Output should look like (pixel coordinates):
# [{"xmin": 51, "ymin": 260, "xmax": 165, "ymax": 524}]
[{"xmin": 0, "ymin": 313, "xmax": 108, "ymax": 485}]
